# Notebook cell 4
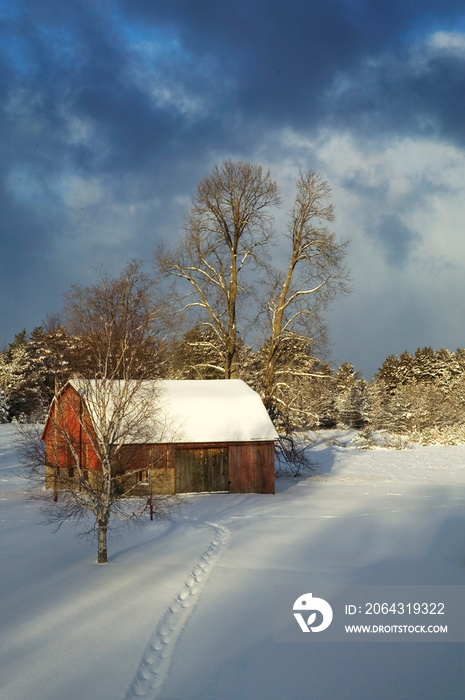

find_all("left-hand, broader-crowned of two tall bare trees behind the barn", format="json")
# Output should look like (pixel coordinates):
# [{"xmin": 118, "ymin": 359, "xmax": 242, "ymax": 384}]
[{"xmin": 155, "ymin": 160, "xmax": 279, "ymax": 379}]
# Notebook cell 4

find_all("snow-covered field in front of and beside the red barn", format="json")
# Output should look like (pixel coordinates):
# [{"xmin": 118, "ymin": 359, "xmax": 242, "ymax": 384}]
[{"xmin": 0, "ymin": 425, "xmax": 465, "ymax": 700}]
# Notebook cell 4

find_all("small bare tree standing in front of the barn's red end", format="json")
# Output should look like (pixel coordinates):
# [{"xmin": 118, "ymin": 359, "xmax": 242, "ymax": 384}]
[{"xmin": 23, "ymin": 262, "xmax": 178, "ymax": 563}]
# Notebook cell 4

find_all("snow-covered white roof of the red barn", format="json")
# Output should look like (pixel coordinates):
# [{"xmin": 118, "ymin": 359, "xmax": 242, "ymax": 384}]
[{"xmin": 66, "ymin": 379, "xmax": 278, "ymax": 443}]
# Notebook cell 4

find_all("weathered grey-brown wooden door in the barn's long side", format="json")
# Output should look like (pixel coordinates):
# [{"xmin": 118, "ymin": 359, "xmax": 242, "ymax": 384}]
[{"xmin": 175, "ymin": 447, "xmax": 229, "ymax": 493}]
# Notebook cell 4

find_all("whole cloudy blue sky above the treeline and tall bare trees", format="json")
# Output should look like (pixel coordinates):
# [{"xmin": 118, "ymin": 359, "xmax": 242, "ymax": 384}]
[{"xmin": 0, "ymin": 0, "xmax": 465, "ymax": 377}]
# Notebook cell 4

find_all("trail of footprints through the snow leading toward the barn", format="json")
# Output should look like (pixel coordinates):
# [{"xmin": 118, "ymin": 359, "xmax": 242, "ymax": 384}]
[{"xmin": 124, "ymin": 518, "xmax": 231, "ymax": 700}]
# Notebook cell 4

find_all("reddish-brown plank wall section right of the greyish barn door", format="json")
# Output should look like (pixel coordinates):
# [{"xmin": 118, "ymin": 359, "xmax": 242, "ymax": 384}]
[{"xmin": 229, "ymin": 442, "xmax": 274, "ymax": 493}]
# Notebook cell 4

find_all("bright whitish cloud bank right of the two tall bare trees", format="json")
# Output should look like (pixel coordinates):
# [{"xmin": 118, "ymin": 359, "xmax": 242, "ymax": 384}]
[{"xmin": 254, "ymin": 129, "xmax": 465, "ymax": 378}]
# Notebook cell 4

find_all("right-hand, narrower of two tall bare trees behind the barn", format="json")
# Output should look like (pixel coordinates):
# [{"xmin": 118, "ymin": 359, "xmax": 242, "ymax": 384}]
[{"xmin": 261, "ymin": 170, "xmax": 349, "ymax": 426}]
